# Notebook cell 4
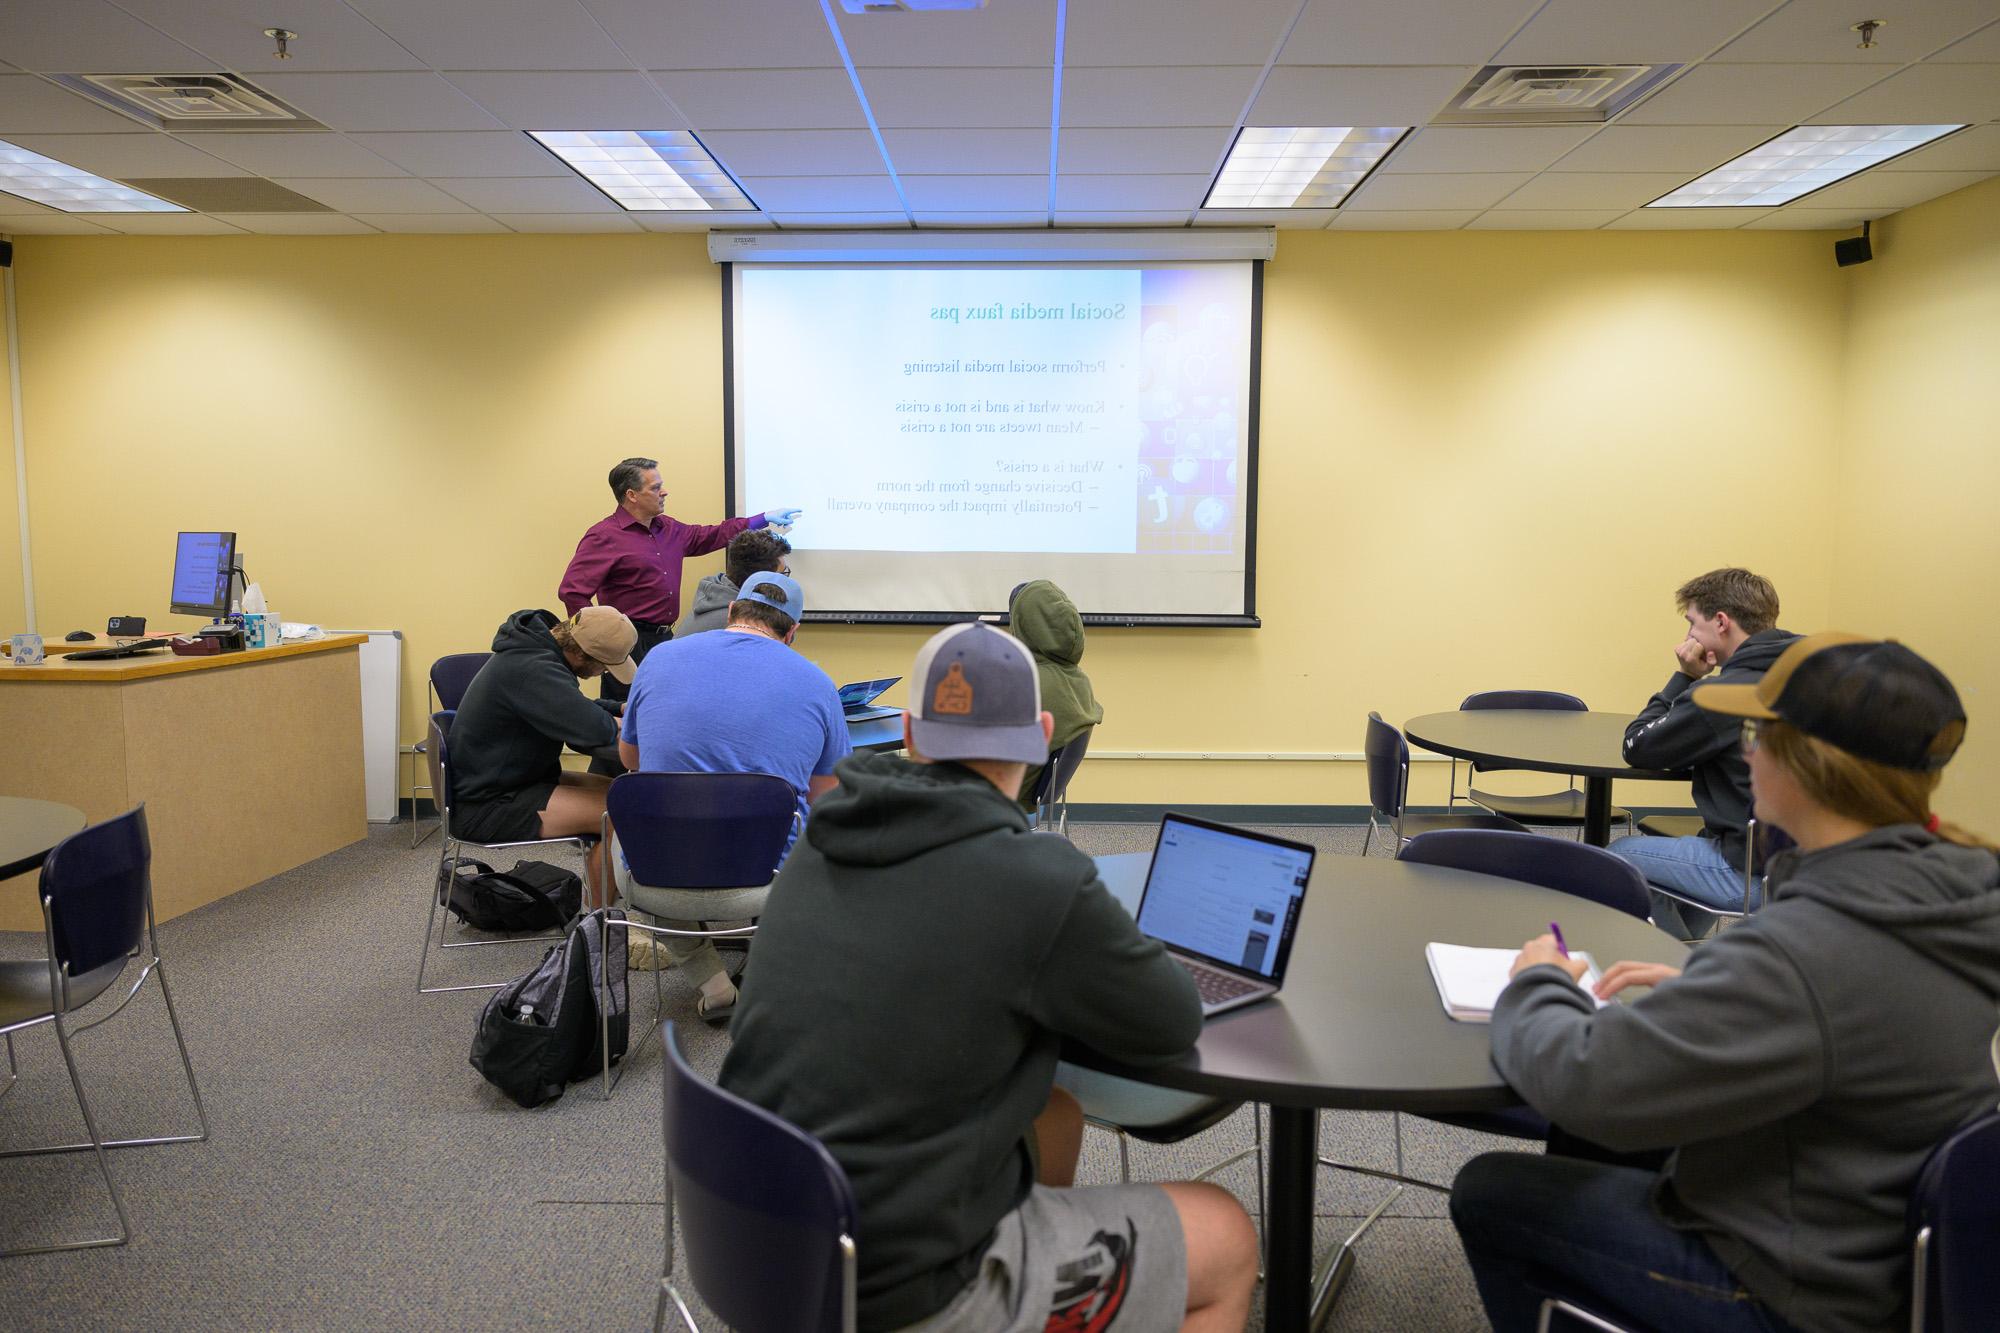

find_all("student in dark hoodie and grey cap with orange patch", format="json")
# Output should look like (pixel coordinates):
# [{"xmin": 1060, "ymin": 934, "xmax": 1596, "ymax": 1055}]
[{"xmin": 720, "ymin": 624, "xmax": 1258, "ymax": 1333}]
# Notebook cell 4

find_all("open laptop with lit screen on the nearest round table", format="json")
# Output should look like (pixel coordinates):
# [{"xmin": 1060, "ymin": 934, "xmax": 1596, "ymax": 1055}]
[{"xmin": 1138, "ymin": 815, "xmax": 1314, "ymax": 1017}]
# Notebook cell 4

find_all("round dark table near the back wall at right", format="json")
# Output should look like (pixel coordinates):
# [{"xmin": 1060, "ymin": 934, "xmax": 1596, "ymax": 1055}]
[{"xmin": 1402, "ymin": 709, "xmax": 1688, "ymax": 847}]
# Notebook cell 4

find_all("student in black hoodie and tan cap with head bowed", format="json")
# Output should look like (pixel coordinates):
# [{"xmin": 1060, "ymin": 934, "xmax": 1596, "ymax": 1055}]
[{"xmin": 450, "ymin": 606, "xmax": 638, "ymax": 907}]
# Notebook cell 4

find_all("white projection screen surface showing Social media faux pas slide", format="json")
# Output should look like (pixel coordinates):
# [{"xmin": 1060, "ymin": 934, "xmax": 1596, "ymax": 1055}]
[{"xmin": 732, "ymin": 264, "xmax": 1252, "ymax": 614}]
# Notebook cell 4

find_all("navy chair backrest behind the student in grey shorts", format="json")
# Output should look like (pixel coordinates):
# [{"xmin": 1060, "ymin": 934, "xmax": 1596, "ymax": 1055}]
[{"xmin": 660, "ymin": 1020, "xmax": 860, "ymax": 1333}]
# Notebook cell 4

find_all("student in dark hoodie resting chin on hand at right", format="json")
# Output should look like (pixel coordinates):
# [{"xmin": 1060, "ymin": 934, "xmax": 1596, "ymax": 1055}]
[{"xmin": 1610, "ymin": 568, "xmax": 1798, "ymax": 939}]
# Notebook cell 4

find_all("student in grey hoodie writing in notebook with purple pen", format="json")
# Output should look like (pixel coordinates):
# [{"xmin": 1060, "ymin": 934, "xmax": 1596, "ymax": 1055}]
[{"xmin": 1452, "ymin": 634, "xmax": 2000, "ymax": 1333}]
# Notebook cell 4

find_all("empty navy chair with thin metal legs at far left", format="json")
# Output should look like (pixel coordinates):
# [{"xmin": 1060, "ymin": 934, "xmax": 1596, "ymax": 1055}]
[{"xmin": 0, "ymin": 807, "xmax": 208, "ymax": 1257}]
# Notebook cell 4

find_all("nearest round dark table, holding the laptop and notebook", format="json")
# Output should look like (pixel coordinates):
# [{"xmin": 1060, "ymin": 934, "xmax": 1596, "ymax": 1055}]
[{"xmin": 1066, "ymin": 853, "xmax": 1688, "ymax": 1329}]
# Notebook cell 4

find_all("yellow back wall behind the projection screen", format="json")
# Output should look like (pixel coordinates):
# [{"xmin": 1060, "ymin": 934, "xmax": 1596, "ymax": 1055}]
[{"xmin": 7, "ymin": 232, "xmax": 1846, "ymax": 803}]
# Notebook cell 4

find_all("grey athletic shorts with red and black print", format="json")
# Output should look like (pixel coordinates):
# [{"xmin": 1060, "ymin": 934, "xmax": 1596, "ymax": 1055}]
[{"xmin": 902, "ymin": 1185, "xmax": 1188, "ymax": 1333}]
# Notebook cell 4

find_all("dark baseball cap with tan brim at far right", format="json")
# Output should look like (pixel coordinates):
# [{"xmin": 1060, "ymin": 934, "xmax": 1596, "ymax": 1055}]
[{"xmin": 1694, "ymin": 632, "xmax": 1966, "ymax": 773}]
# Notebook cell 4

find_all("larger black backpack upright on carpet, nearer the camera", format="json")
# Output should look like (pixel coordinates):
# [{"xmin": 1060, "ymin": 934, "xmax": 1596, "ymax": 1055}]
[{"xmin": 468, "ymin": 909, "xmax": 632, "ymax": 1107}]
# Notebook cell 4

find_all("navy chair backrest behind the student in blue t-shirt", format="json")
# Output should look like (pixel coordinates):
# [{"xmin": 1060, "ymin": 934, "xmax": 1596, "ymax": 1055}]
[{"xmin": 604, "ymin": 773, "xmax": 798, "ymax": 889}]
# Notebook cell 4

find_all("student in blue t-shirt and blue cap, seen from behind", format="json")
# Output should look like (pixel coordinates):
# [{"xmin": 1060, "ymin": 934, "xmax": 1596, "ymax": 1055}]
[{"xmin": 612, "ymin": 572, "xmax": 850, "ymax": 1023}]
